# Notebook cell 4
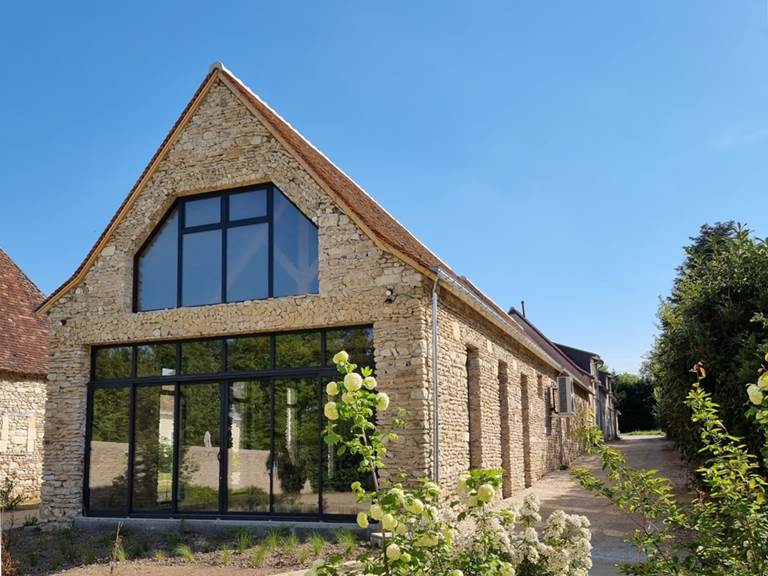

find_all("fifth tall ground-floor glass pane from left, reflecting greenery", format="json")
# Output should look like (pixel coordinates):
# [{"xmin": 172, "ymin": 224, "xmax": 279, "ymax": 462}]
[{"xmin": 272, "ymin": 378, "xmax": 322, "ymax": 513}]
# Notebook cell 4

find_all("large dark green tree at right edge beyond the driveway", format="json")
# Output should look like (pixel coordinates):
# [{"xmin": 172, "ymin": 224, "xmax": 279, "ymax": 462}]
[{"xmin": 649, "ymin": 222, "xmax": 768, "ymax": 461}]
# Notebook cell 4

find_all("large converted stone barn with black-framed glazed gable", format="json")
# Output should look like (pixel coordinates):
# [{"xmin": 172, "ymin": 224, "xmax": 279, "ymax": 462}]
[{"xmin": 40, "ymin": 64, "xmax": 594, "ymax": 523}]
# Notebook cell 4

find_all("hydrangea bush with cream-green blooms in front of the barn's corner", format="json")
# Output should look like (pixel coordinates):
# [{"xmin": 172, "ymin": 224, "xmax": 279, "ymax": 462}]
[{"xmin": 307, "ymin": 351, "xmax": 592, "ymax": 576}]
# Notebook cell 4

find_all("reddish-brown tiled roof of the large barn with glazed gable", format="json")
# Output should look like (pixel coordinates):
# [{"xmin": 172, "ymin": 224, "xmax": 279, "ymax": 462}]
[{"xmin": 39, "ymin": 63, "xmax": 576, "ymax": 378}]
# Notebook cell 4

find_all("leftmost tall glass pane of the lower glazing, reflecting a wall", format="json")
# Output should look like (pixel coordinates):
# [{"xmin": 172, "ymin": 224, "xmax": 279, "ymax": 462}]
[{"xmin": 88, "ymin": 388, "xmax": 130, "ymax": 512}]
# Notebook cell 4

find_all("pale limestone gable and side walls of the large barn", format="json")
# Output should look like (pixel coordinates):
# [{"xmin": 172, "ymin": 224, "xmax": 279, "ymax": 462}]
[{"xmin": 41, "ymin": 75, "xmax": 592, "ymax": 523}]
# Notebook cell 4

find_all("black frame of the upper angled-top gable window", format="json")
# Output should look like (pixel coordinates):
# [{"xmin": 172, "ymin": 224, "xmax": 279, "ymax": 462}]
[{"xmin": 131, "ymin": 183, "xmax": 319, "ymax": 313}]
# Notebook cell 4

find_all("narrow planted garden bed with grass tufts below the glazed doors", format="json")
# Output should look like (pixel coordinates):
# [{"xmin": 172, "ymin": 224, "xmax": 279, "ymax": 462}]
[{"xmin": 10, "ymin": 527, "xmax": 363, "ymax": 576}]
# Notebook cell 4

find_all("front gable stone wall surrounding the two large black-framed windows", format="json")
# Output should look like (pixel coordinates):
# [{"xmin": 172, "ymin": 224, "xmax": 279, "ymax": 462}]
[{"xmin": 42, "ymin": 77, "xmax": 429, "ymax": 522}]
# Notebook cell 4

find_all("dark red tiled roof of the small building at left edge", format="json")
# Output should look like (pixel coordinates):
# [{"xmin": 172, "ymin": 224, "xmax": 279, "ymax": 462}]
[{"xmin": 0, "ymin": 249, "xmax": 48, "ymax": 376}]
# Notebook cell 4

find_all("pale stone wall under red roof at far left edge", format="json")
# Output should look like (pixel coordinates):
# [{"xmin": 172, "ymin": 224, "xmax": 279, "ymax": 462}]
[{"xmin": 0, "ymin": 374, "xmax": 45, "ymax": 499}]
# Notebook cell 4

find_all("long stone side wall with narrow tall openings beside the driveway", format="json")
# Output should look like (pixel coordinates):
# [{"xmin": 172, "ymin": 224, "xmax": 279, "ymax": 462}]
[{"xmin": 436, "ymin": 291, "xmax": 590, "ymax": 494}]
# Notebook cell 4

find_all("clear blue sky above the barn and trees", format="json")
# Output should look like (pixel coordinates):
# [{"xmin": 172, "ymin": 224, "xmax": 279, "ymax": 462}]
[{"xmin": 0, "ymin": 0, "xmax": 768, "ymax": 370}]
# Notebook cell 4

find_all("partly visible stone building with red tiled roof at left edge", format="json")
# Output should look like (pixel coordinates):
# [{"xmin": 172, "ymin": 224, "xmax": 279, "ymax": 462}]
[{"xmin": 0, "ymin": 250, "xmax": 48, "ymax": 500}]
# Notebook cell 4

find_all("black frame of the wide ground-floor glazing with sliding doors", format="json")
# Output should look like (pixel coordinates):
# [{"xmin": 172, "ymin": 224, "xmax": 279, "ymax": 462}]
[{"xmin": 82, "ymin": 324, "xmax": 375, "ymax": 522}]
